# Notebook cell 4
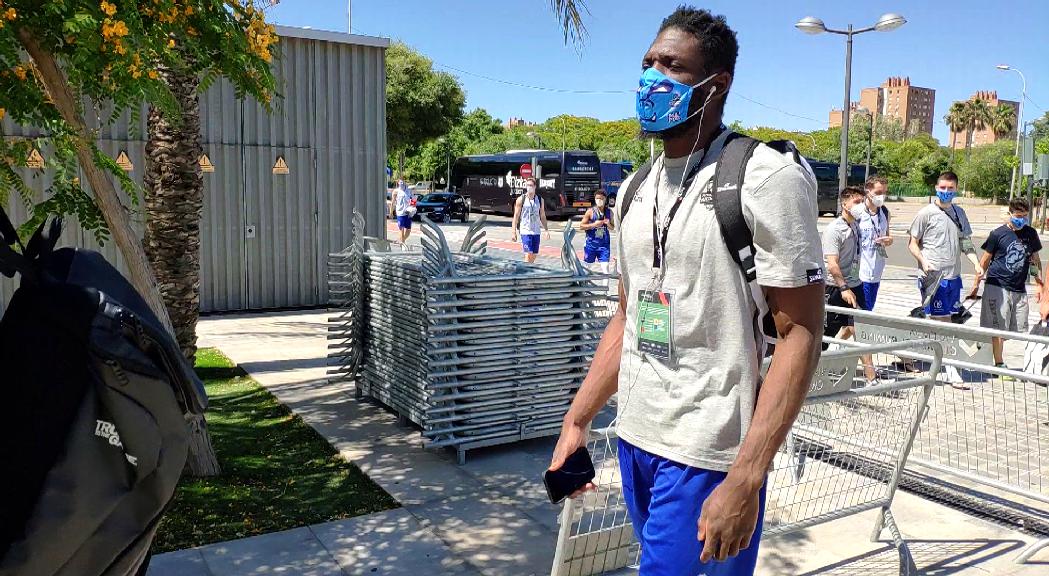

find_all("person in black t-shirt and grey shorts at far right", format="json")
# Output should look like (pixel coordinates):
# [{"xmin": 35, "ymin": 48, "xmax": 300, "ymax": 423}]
[{"xmin": 977, "ymin": 198, "xmax": 1042, "ymax": 367}]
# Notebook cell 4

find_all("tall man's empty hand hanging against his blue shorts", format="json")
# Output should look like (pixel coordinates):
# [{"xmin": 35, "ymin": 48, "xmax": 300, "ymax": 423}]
[{"xmin": 698, "ymin": 475, "xmax": 761, "ymax": 562}]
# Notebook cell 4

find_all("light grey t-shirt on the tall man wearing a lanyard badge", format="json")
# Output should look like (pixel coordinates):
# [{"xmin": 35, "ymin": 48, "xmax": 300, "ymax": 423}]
[{"xmin": 616, "ymin": 131, "xmax": 822, "ymax": 471}]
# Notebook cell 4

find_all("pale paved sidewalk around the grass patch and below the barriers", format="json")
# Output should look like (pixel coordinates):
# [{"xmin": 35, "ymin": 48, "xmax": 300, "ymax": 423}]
[{"xmin": 150, "ymin": 297, "xmax": 1049, "ymax": 576}]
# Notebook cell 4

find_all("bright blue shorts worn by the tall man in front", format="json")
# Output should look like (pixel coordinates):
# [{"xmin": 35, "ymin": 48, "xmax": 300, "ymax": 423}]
[{"xmin": 619, "ymin": 440, "xmax": 765, "ymax": 576}]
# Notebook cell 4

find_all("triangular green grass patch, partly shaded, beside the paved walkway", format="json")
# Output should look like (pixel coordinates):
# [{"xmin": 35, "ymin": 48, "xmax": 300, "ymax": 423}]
[{"xmin": 154, "ymin": 349, "xmax": 398, "ymax": 553}]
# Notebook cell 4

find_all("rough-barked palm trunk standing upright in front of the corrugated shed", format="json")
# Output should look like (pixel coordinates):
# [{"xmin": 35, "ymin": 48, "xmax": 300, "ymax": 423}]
[{"xmin": 143, "ymin": 63, "xmax": 221, "ymax": 476}]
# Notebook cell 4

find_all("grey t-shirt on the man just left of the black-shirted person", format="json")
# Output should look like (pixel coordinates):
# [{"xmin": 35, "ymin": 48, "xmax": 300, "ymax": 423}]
[{"xmin": 908, "ymin": 204, "xmax": 972, "ymax": 280}]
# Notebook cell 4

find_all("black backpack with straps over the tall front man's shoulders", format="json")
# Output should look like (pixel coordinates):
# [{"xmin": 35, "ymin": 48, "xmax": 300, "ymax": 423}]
[{"xmin": 619, "ymin": 132, "xmax": 805, "ymax": 344}]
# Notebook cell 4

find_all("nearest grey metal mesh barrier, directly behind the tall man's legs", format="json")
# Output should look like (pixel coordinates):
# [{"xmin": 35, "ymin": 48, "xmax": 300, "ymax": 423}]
[{"xmin": 551, "ymin": 340, "xmax": 941, "ymax": 576}]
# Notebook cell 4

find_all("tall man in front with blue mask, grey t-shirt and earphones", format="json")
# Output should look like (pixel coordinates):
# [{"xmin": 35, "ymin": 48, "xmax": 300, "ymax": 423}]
[{"xmin": 551, "ymin": 6, "xmax": 823, "ymax": 576}]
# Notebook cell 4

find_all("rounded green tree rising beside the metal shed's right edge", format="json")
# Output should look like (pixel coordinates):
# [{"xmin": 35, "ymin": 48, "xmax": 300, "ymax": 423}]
[{"xmin": 386, "ymin": 42, "xmax": 466, "ymax": 171}]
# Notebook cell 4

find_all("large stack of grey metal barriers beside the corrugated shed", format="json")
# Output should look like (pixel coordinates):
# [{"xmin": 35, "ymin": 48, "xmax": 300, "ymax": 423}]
[{"xmin": 331, "ymin": 210, "xmax": 607, "ymax": 462}]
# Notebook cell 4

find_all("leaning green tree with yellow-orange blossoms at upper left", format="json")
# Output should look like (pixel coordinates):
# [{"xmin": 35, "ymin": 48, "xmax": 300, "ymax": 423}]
[{"xmin": 0, "ymin": 0, "xmax": 276, "ymax": 472}]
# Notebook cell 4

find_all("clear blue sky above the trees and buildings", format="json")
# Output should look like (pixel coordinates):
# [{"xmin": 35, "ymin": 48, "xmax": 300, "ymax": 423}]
[{"xmin": 270, "ymin": 0, "xmax": 1049, "ymax": 143}]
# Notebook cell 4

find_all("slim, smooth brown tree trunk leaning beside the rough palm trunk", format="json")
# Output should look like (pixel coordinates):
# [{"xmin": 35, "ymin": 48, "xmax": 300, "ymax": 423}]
[{"xmin": 18, "ymin": 29, "xmax": 217, "ymax": 473}]
